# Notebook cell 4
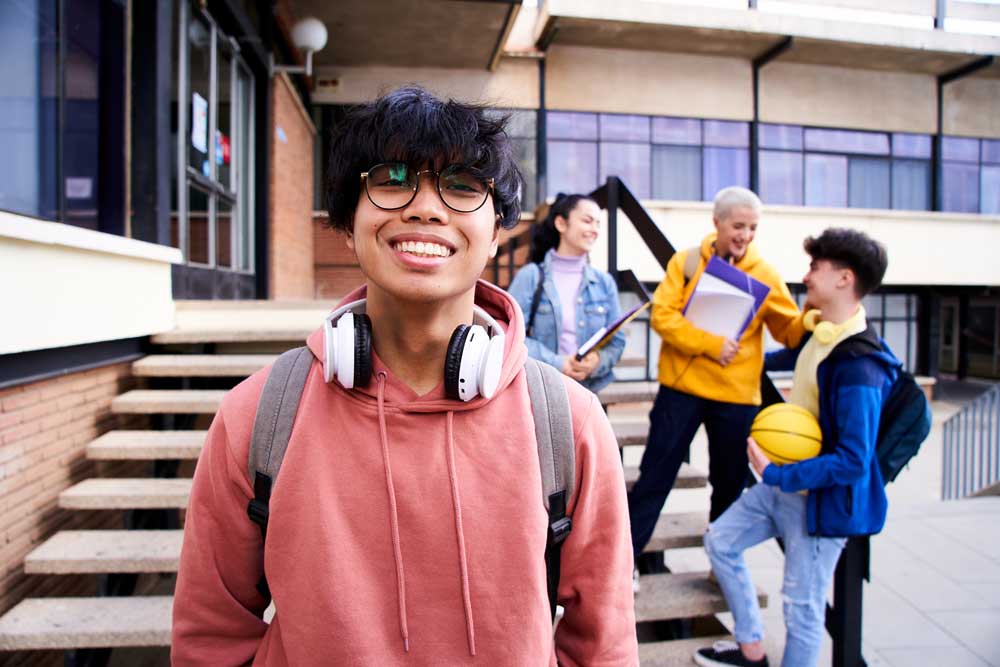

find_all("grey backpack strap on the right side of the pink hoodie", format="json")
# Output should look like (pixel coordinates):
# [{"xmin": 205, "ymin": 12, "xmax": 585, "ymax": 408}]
[{"xmin": 524, "ymin": 359, "xmax": 576, "ymax": 619}]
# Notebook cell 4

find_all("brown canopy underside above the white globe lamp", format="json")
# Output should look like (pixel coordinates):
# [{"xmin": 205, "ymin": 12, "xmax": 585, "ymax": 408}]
[{"xmin": 292, "ymin": 0, "xmax": 521, "ymax": 69}]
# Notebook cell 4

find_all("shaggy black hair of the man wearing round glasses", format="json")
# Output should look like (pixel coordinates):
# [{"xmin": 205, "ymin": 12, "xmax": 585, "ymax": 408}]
[{"xmin": 326, "ymin": 86, "xmax": 521, "ymax": 231}]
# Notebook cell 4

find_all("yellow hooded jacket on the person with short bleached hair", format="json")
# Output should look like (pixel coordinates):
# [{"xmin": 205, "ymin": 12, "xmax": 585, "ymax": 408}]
[{"xmin": 650, "ymin": 233, "xmax": 805, "ymax": 405}]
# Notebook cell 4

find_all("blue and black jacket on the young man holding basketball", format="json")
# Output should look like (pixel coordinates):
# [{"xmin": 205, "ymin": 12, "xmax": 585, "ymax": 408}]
[{"xmin": 763, "ymin": 324, "xmax": 902, "ymax": 537}]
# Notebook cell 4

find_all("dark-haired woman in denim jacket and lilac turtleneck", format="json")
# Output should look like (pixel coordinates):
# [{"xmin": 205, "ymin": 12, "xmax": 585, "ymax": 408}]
[{"xmin": 509, "ymin": 194, "xmax": 625, "ymax": 392}]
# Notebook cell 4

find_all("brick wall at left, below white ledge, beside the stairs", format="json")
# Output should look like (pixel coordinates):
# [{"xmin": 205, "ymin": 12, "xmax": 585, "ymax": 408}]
[{"xmin": 0, "ymin": 363, "xmax": 147, "ymax": 628}]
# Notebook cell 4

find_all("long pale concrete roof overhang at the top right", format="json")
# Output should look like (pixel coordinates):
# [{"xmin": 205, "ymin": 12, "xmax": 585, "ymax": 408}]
[{"xmin": 535, "ymin": 0, "xmax": 1000, "ymax": 76}]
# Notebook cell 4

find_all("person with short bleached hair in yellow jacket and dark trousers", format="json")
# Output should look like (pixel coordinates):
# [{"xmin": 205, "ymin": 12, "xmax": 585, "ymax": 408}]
[{"xmin": 629, "ymin": 187, "xmax": 804, "ymax": 584}]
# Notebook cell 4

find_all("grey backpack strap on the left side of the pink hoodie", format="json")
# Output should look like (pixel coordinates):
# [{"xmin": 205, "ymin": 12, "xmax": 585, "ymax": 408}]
[{"xmin": 247, "ymin": 347, "xmax": 312, "ymax": 599}]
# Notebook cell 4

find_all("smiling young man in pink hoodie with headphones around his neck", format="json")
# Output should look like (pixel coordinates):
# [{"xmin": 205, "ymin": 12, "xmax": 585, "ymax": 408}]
[{"xmin": 172, "ymin": 88, "xmax": 638, "ymax": 667}]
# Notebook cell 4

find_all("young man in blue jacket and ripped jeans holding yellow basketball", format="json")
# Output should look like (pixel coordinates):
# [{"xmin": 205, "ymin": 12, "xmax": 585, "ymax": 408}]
[{"xmin": 694, "ymin": 229, "xmax": 901, "ymax": 667}]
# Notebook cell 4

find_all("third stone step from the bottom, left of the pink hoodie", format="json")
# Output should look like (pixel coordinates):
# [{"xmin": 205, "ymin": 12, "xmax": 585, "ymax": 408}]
[{"xmin": 59, "ymin": 477, "xmax": 191, "ymax": 510}]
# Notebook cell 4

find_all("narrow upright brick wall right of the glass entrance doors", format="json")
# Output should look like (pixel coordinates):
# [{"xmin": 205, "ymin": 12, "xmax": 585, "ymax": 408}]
[{"xmin": 268, "ymin": 74, "xmax": 316, "ymax": 299}]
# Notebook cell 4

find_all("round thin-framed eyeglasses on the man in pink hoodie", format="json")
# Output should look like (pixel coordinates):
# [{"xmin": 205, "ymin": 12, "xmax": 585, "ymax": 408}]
[{"xmin": 361, "ymin": 162, "xmax": 493, "ymax": 213}]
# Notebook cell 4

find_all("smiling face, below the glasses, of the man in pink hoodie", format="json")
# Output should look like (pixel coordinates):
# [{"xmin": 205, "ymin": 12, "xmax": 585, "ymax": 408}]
[{"xmin": 347, "ymin": 166, "xmax": 499, "ymax": 303}]
